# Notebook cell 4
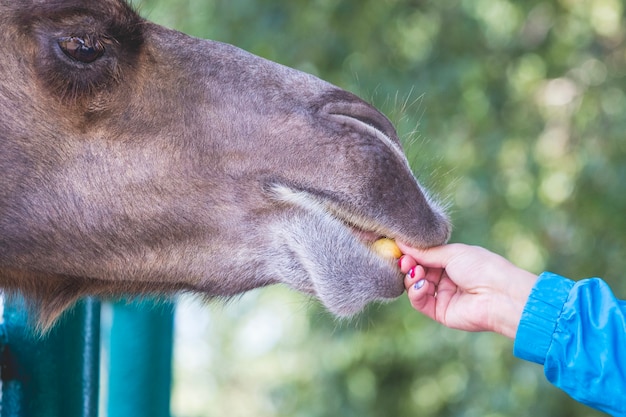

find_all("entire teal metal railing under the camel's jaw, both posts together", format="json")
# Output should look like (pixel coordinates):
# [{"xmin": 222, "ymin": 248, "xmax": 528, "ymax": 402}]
[{"xmin": 0, "ymin": 297, "xmax": 174, "ymax": 417}]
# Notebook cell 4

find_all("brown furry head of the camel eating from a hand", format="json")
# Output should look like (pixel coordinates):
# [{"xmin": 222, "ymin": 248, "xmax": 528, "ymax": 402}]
[{"xmin": 0, "ymin": 0, "xmax": 449, "ymax": 328}]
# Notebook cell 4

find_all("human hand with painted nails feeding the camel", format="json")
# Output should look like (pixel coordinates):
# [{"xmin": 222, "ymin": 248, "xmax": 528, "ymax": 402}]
[{"xmin": 398, "ymin": 242, "xmax": 537, "ymax": 339}]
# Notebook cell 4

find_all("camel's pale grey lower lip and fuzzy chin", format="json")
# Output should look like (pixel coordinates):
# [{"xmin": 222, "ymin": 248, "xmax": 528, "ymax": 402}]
[{"xmin": 266, "ymin": 182, "xmax": 404, "ymax": 317}]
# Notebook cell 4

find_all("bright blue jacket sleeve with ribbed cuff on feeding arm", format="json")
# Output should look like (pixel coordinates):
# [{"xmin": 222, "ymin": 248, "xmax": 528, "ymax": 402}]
[{"xmin": 513, "ymin": 272, "xmax": 626, "ymax": 416}]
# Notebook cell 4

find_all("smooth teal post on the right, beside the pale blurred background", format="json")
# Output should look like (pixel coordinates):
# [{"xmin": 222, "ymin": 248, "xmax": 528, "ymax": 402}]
[{"xmin": 107, "ymin": 301, "xmax": 174, "ymax": 417}]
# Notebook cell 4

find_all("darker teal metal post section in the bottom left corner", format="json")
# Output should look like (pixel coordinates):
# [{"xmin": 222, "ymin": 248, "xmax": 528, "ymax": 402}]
[{"xmin": 1, "ymin": 297, "xmax": 100, "ymax": 417}]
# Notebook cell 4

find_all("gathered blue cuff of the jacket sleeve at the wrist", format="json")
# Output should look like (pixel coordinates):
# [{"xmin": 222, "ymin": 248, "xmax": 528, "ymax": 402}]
[{"xmin": 513, "ymin": 272, "xmax": 574, "ymax": 365}]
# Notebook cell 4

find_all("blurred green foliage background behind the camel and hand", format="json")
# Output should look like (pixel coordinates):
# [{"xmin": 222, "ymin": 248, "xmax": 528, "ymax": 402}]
[{"xmin": 130, "ymin": 0, "xmax": 626, "ymax": 417}]
